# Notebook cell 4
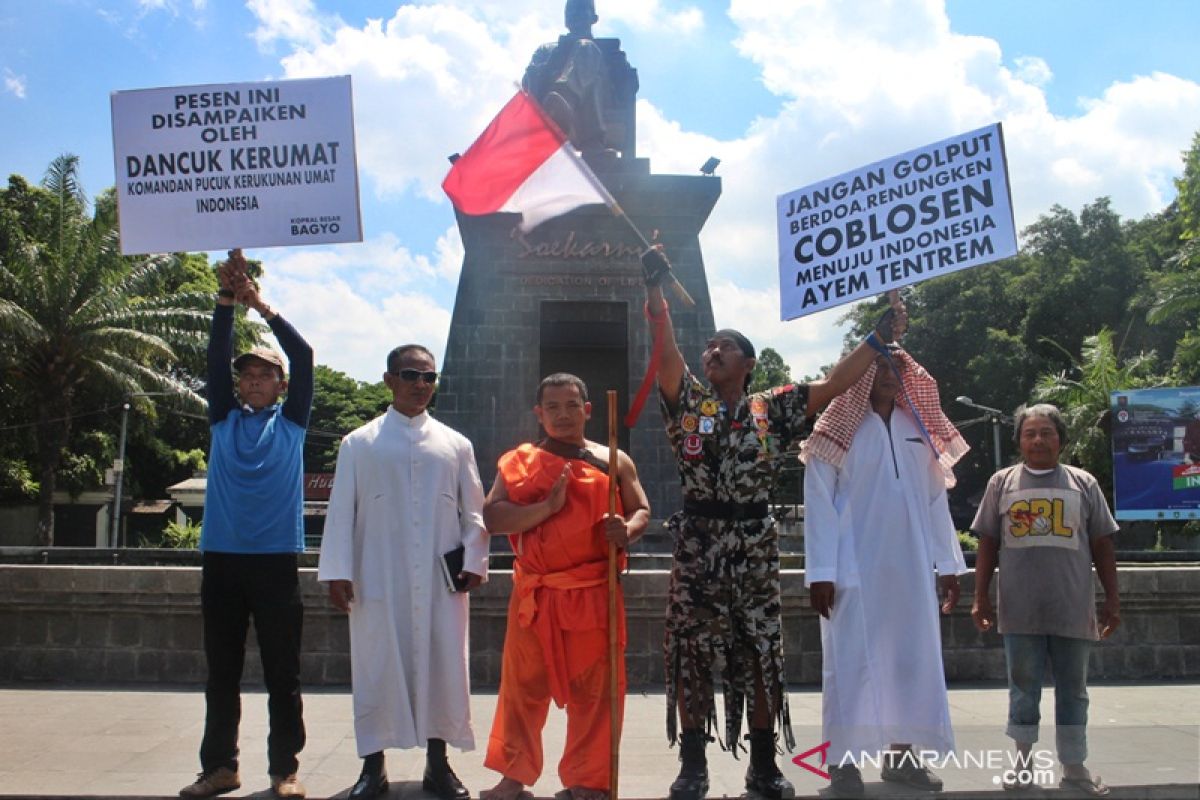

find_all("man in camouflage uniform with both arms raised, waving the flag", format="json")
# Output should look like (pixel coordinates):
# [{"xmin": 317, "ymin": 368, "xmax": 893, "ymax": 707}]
[{"xmin": 642, "ymin": 249, "xmax": 905, "ymax": 800}]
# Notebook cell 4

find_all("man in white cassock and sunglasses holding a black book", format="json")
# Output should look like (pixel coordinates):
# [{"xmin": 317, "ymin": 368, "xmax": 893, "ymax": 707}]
[{"xmin": 317, "ymin": 344, "xmax": 488, "ymax": 800}]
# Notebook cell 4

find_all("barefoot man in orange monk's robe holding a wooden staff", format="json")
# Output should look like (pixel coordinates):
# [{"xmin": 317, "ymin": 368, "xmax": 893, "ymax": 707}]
[{"xmin": 480, "ymin": 373, "xmax": 650, "ymax": 800}]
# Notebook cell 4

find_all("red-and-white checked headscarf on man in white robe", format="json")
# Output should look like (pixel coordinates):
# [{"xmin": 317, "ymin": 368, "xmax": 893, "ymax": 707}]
[{"xmin": 800, "ymin": 349, "xmax": 971, "ymax": 488}]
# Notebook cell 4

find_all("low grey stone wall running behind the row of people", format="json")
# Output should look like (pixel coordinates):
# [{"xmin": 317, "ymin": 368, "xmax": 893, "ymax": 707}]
[{"xmin": 0, "ymin": 565, "xmax": 1200, "ymax": 690}]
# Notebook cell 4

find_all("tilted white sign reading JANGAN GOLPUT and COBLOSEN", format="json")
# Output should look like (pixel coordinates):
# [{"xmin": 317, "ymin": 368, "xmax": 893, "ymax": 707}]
[{"xmin": 776, "ymin": 122, "xmax": 1016, "ymax": 320}]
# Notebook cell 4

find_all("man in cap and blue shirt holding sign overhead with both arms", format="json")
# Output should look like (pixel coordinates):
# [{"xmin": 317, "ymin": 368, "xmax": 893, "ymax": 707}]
[{"xmin": 180, "ymin": 249, "xmax": 313, "ymax": 798}]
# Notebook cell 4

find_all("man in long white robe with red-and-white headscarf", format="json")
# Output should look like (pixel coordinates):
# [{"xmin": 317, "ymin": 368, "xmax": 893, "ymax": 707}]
[{"xmin": 802, "ymin": 348, "xmax": 967, "ymax": 798}]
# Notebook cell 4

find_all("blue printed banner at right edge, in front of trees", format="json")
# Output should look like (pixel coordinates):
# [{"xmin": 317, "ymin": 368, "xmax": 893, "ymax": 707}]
[{"xmin": 1112, "ymin": 386, "xmax": 1200, "ymax": 519}]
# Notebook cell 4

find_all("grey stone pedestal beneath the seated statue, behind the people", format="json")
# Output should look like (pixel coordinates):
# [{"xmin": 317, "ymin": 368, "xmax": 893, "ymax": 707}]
[{"xmin": 434, "ymin": 158, "xmax": 721, "ymax": 518}]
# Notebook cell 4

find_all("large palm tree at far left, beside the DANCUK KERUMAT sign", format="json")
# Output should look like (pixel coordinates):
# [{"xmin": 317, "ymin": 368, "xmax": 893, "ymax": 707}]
[{"xmin": 0, "ymin": 155, "xmax": 211, "ymax": 545}]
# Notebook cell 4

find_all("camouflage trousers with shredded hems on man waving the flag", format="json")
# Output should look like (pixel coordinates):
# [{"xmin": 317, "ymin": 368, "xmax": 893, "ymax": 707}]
[{"xmin": 664, "ymin": 513, "xmax": 796, "ymax": 754}]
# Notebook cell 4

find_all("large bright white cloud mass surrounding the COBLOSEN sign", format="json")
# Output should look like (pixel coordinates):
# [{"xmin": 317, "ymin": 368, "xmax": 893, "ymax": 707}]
[{"xmin": 638, "ymin": 0, "xmax": 1200, "ymax": 375}]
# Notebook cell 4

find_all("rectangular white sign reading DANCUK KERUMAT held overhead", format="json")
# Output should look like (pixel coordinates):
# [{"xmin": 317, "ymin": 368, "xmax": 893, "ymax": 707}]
[{"xmin": 112, "ymin": 76, "xmax": 362, "ymax": 255}]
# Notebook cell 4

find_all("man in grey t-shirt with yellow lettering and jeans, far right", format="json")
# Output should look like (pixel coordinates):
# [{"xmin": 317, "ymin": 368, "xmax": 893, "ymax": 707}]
[{"xmin": 971, "ymin": 404, "xmax": 1121, "ymax": 796}]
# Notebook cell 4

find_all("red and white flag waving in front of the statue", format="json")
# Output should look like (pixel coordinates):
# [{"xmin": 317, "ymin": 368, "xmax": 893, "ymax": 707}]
[{"xmin": 442, "ymin": 91, "xmax": 613, "ymax": 233}]
